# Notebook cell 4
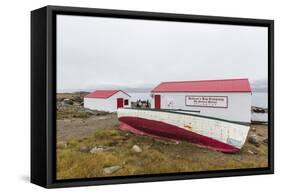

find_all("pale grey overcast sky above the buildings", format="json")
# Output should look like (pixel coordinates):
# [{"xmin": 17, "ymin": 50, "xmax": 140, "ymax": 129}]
[{"xmin": 57, "ymin": 15, "xmax": 267, "ymax": 90}]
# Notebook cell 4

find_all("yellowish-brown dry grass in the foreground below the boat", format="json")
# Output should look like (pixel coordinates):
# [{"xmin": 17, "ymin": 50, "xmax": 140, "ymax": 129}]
[{"xmin": 57, "ymin": 126, "xmax": 267, "ymax": 179}]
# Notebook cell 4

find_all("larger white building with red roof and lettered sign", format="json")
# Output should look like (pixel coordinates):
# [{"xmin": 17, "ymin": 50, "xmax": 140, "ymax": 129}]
[{"xmin": 151, "ymin": 79, "xmax": 252, "ymax": 122}]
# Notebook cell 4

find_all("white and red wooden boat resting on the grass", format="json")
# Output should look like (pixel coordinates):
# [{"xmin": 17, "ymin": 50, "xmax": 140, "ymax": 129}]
[{"xmin": 117, "ymin": 108, "xmax": 250, "ymax": 153}]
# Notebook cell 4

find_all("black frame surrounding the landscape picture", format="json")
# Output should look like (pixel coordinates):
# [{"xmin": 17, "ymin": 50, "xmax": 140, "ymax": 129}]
[{"xmin": 31, "ymin": 6, "xmax": 274, "ymax": 188}]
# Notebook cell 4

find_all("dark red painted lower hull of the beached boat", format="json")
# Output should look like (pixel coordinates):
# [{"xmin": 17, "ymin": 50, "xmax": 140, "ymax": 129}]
[{"xmin": 119, "ymin": 117, "xmax": 240, "ymax": 153}]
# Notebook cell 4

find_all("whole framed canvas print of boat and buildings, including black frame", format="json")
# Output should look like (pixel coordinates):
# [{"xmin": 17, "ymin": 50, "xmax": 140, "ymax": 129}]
[{"xmin": 31, "ymin": 6, "xmax": 274, "ymax": 188}]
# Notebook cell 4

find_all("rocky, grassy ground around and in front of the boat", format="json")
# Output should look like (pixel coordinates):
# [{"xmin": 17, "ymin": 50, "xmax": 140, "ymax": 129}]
[{"xmin": 57, "ymin": 93, "xmax": 268, "ymax": 179}]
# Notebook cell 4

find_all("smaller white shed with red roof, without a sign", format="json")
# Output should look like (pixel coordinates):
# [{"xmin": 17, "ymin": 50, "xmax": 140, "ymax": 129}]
[{"xmin": 84, "ymin": 90, "xmax": 131, "ymax": 112}]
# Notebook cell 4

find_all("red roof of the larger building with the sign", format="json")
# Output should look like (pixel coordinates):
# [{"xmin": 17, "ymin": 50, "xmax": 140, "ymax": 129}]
[{"xmin": 151, "ymin": 79, "xmax": 251, "ymax": 92}]
